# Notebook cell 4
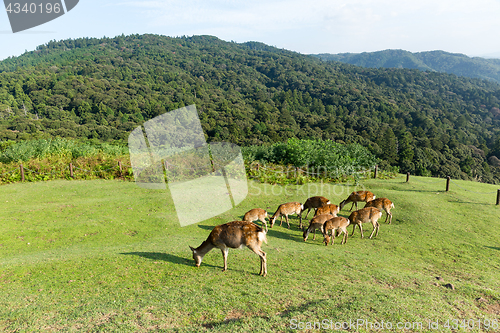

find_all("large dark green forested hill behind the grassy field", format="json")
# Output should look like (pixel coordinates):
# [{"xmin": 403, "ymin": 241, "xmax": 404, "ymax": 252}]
[{"xmin": 0, "ymin": 35, "xmax": 500, "ymax": 182}]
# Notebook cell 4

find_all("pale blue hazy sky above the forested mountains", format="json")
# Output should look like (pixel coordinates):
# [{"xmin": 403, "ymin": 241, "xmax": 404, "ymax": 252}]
[{"xmin": 0, "ymin": 0, "xmax": 500, "ymax": 60}]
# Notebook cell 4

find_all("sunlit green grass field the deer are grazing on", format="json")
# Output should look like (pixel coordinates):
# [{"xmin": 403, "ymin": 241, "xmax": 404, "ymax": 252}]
[{"xmin": 0, "ymin": 176, "xmax": 500, "ymax": 332}]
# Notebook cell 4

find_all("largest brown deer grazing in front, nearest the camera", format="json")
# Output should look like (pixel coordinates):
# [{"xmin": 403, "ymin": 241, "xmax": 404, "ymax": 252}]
[{"xmin": 189, "ymin": 221, "xmax": 267, "ymax": 276}]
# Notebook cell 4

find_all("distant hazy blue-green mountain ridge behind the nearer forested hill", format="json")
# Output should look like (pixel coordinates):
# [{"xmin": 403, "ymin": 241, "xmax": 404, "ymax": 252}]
[{"xmin": 314, "ymin": 50, "xmax": 500, "ymax": 83}]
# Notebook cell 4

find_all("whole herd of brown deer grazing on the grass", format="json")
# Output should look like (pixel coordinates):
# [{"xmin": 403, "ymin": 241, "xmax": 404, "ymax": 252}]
[{"xmin": 190, "ymin": 191, "xmax": 394, "ymax": 276}]
